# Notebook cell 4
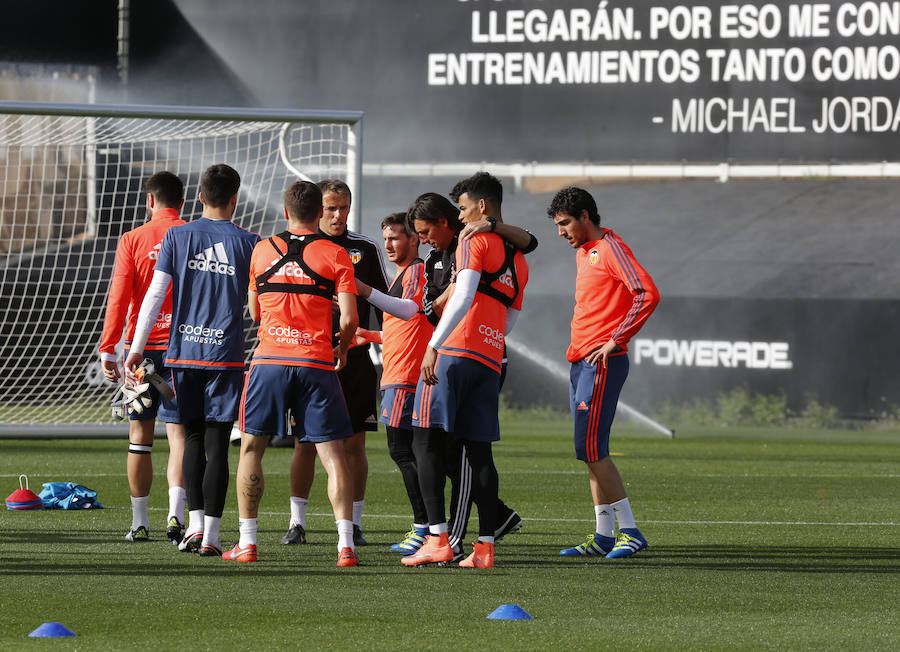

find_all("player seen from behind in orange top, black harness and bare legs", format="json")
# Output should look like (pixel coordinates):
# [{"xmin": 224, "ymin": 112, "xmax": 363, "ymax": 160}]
[{"xmin": 222, "ymin": 181, "xmax": 358, "ymax": 566}]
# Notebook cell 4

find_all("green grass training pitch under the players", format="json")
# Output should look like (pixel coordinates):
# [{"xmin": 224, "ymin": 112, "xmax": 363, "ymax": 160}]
[{"xmin": 0, "ymin": 415, "xmax": 900, "ymax": 650}]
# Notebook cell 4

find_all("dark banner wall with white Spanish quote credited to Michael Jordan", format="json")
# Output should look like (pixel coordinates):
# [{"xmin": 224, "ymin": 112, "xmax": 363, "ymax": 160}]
[{"xmin": 165, "ymin": 0, "xmax": 900, "ymax": 162}]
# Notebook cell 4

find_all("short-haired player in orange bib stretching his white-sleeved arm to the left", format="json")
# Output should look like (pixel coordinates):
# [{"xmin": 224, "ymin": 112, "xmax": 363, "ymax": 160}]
[{"xmin": 356, "ymin": 213, "xmax": 433, "ymax": 555}]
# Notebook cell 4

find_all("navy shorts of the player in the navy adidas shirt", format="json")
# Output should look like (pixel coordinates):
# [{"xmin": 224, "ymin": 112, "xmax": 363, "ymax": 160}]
[{"xmin": 172, "ymin": 367, "xmax": 244, "ymax": 423}]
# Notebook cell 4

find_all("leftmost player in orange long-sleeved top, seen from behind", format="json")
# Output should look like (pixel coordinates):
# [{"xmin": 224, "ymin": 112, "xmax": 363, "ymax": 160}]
[{"xmin": 99, "ymin": 172, "xmax": 185, "ymax": 544}]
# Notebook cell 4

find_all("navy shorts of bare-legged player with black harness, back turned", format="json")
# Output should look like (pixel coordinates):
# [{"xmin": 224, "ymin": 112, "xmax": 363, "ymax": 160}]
[{"xmin": 239, "ymin": 364, "xmax": 353, "ymax": 443}]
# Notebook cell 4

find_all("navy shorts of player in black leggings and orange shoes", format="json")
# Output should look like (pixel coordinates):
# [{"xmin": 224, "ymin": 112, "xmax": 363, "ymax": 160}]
[{"xmin": 412, "ymin": 354, "xmax": 500, "ymax": 442}]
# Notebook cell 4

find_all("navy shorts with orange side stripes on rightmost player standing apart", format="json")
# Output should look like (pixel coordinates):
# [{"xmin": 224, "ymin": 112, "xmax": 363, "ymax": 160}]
[{"xmin": 569, "ymin": 353, "xmax": 628, "ymax": 462}]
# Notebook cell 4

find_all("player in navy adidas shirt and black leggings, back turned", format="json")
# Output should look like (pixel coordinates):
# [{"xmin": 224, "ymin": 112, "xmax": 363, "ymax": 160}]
[{"xmin": 125, "ymin": 164, "xmax": 259, "ymax": 557}]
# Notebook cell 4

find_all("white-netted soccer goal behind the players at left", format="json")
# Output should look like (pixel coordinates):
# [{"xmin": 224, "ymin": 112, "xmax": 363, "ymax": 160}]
[{"xmin": 0, "ymin": 102, "xmax": 362, "ymax": 437}]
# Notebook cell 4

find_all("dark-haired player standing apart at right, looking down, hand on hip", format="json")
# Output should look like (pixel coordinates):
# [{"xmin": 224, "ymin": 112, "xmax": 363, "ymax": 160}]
[{"xmin": 547, "ymin": 188, "xmax": 659, "ymax": 559}]
